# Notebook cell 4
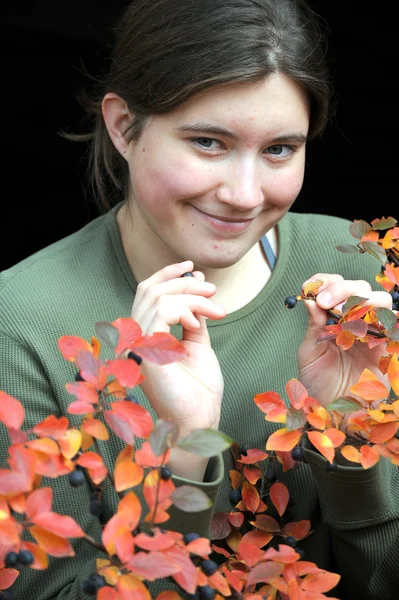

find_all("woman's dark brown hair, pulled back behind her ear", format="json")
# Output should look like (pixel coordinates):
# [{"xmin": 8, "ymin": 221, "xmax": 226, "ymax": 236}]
[{"xmin": 66, "ymin": 0, "xmax": 331, "ymax": 211}]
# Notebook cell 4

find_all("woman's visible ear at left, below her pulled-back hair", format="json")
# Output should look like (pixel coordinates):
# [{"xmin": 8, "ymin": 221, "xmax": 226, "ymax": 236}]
[{"xmin": 101, "ymin": 92, "xmax": 132, "ymax": 157}]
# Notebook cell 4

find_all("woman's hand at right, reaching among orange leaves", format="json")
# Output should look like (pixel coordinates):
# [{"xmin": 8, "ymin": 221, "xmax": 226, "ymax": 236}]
[{"xmin": 298, "ymin": 273, "xmax": 392, "ymax": 406}]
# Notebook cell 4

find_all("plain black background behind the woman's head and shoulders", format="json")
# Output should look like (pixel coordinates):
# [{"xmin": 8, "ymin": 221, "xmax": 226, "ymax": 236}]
[{"xmin": 0, "ymin": 0, "xmax": 399, "ymax": 270}]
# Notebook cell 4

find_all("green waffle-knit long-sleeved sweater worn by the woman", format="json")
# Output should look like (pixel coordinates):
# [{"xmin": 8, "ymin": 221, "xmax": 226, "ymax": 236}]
[{"xmin": 0, "ymin": 207, "xmax": 399, "ymax": 600}]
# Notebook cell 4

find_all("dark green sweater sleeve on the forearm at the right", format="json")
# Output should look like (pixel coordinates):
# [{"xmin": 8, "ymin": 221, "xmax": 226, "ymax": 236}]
[{"xmin": 305, "ymin": 449, "xmax": 399, "ymax": 600}]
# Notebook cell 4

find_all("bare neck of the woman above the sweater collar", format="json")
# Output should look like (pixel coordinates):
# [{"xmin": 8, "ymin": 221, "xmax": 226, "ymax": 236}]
[{"xmin": 117, "ymin": 204, "xmax": 277, "ymax": 313}]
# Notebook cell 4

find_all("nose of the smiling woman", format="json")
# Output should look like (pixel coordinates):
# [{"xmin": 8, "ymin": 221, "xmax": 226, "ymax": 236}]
[{"xmin": 216, "ymin": 157, "xmax": 264, "ymax": 212}]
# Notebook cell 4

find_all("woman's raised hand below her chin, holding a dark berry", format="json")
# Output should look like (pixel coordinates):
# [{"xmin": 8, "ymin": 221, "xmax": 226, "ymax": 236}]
[{"xmin": 131, "ymin": 261, "xmax": 226, "ymax": 435}]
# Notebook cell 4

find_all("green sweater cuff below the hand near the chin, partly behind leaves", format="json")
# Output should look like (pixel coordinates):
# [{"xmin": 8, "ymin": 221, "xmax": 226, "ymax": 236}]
[{"xmin": 163, "ymin": 454, "xmax": 224, "ymax": 538}]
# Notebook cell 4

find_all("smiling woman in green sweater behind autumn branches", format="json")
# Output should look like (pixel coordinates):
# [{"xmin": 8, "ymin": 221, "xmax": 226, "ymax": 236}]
[{"xmin": 0, "ymin": 0, "xmax": 399, "ymax": 600}]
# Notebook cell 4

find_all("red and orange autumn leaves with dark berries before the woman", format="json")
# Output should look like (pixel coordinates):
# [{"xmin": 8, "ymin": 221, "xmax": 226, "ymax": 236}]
[{"xmin": 0, "ymin": 217, "xmax": 399, "ymax": 600}]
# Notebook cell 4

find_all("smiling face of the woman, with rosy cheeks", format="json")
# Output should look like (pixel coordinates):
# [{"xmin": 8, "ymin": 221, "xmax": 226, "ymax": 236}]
[{"xmin": 125, "ymin": 75, "xmax": 309, "ymax": 269}]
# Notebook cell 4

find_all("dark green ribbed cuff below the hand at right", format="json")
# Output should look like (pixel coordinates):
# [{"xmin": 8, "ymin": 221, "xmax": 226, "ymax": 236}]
[{"xmin": 304, "ymin": 448, "xmax": 393, "ymax": 530}]
